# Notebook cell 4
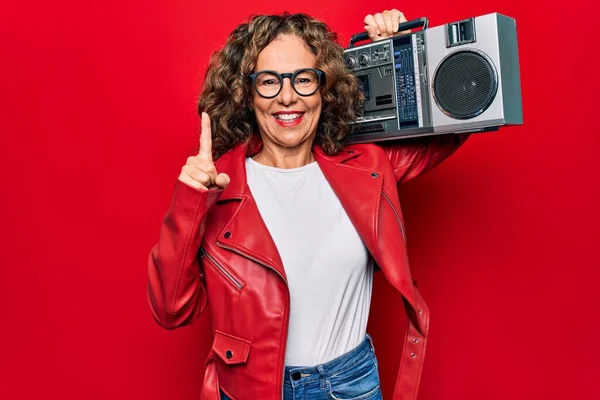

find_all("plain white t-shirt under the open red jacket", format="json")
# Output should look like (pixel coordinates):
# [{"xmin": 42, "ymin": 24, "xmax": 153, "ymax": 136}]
[{"xmin": 246, "ymin": 158, "xmax": 373, "ymax": 366}]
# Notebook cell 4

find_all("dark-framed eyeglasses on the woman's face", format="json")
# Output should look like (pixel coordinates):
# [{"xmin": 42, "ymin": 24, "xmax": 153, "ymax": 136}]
[{"xmin": 248, "ymin": 68, "xmax": 325, "ymax": 99}]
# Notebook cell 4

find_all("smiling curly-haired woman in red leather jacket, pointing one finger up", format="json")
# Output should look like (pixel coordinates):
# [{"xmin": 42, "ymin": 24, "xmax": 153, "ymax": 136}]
[{"xmin": 148, "ymin": 10, "xmax": 463, "ymax": 400}]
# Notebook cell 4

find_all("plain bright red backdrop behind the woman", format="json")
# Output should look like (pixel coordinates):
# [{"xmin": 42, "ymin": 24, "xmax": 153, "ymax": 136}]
[{"xmin": 0, "ymin": 0, "xmax": 600, "ymax": 400}]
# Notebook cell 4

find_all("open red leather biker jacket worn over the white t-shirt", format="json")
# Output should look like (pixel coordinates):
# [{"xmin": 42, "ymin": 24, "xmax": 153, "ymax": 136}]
[{"xmin": 148, "ymin": 135, "xmax": 466, "ymax": 400}]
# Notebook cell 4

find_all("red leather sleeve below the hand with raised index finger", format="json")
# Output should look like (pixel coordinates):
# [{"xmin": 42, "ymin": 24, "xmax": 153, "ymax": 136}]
[{"xmin": 148, "ymin": 181, "xmax": 222, "ymax": 329}]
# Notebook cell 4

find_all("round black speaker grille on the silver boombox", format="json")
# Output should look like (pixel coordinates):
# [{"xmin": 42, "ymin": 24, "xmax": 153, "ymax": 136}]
[{"xmin": 433, "ymin": 50, "xmax": 498, "ymax": 119}]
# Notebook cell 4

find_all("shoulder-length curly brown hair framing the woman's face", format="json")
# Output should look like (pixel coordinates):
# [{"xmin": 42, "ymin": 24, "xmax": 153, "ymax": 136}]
[{"xmin": 198, "ymin": 12, "xmax": 364, "ymax": 158}]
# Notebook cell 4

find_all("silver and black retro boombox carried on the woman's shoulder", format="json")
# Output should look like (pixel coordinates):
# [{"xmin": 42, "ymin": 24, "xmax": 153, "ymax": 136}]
[{"xmin": 344, "ymin": 13, "xmax": 523, "ymax": 143}]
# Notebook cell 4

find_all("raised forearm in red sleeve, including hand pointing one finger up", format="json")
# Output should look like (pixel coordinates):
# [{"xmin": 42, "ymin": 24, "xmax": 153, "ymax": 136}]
[{"xmin": 148, "ymin": 113, "xmax": 229, "ymax": 329}]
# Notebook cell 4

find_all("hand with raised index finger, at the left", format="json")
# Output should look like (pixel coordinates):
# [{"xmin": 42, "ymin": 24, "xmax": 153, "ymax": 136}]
[{"xmin": 179, "ymin": 112, "xmax": 230, "ymax": 190}]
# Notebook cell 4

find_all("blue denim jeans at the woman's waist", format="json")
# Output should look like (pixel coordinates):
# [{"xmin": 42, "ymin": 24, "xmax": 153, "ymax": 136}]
[{"xmin": 221, "ymin": 335, "xmax": 382, "ymax": 400}]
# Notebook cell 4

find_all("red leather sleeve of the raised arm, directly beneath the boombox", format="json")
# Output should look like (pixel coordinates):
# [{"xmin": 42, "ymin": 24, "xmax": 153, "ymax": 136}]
[{"xmin": 382, "ymin": 134, "xmax": 469, "ymax": 184}]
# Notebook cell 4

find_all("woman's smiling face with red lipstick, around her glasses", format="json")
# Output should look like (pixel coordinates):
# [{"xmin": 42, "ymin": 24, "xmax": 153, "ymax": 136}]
[{"xmin": 252, "ymin": 35, "xmax": 322, "ymax": 153}]
